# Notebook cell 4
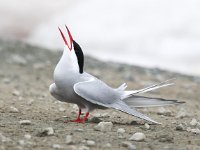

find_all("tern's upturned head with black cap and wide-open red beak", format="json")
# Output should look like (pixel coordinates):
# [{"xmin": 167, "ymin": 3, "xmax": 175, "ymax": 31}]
[{"xmin": 58, "ymin": 26, "xmax": 84, "ymax": 73}]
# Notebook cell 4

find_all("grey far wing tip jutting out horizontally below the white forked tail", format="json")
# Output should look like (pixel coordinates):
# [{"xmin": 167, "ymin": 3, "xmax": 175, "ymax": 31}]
[{"xmin": 123, "ymin": 96, "xmax": 185, "ymax": 108}]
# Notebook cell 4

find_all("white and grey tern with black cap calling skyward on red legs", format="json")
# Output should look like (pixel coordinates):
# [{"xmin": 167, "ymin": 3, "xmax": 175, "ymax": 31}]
[{"xmin": 49, "ymin": 26, "xmax": 182, "ymax": 124}]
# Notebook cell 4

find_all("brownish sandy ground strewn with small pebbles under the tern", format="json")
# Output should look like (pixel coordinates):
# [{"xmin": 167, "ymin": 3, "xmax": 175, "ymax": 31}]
[{"xmin": 0, "ymin": 41, "xmax": 200, "ymax": 150}]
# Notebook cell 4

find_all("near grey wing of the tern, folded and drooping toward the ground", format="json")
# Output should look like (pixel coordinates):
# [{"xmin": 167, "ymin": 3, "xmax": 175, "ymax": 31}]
[{"xmin": 74, "ymin": 78, "xmax": 158, "ymax": 123}]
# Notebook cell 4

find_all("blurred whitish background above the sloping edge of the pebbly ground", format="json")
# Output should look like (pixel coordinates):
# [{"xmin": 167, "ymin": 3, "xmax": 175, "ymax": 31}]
[{"xmin": 0, "ymin": 0, "xmax": 200, "ymax": 75}]
